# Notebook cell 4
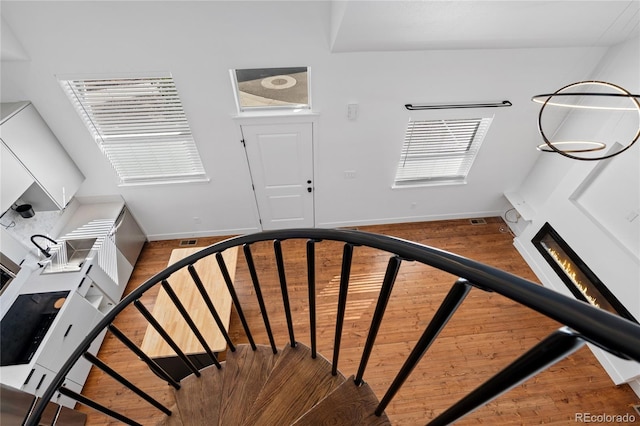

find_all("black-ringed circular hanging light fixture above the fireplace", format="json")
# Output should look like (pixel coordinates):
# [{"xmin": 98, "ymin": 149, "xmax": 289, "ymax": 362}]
[{"xmin": 531, "ymin": 81, "xmax": 640, "ymax": 161}]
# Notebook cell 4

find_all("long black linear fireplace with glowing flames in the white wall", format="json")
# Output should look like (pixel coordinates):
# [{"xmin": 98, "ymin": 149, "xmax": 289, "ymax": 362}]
[{"xmin": 531, "ymin": 223, "xmax": 638, "ymax": 323}]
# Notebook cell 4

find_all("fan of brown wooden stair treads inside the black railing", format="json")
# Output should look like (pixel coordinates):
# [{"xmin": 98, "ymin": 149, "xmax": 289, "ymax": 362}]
[{"xmin": 160, "ymin": 343, "xmax": 391, "ymax": 425}]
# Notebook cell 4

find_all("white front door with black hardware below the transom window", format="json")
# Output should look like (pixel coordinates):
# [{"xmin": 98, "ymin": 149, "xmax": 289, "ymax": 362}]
[{"xmin": 242, "ymin": 123, "xmax": 314, "ymax": 230}]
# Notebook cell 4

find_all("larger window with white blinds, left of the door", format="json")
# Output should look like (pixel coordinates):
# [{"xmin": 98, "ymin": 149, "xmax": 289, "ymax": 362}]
[{"xmin": 60, "ymin": 74, "xmax": 208, "ymax": 184}]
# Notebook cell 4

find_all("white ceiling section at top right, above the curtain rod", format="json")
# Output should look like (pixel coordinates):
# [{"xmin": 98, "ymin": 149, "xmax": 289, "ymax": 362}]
[{"xmin": 332, "ymin": 0, "xmax": 640, "ymax": 52}]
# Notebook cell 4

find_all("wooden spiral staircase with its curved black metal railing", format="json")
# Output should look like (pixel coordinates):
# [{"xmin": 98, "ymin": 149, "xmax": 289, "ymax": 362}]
[{"xmin": 24, "ymin": 229, "xmax": 640, "ymax": 426}]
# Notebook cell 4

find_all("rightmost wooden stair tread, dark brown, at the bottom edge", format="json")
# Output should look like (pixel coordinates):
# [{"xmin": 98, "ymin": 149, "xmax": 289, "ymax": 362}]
[{"xmin": 294, "ymin": 376, "xmax": 391, "ymax": 426}]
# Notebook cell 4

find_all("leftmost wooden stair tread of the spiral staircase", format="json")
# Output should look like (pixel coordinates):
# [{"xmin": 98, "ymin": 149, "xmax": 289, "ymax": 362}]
[{"xmin": 166, "ymin": 363, "xmax": 225, "ymax": 426}]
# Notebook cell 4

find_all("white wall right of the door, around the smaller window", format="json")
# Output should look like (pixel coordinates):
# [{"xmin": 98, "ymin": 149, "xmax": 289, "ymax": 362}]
[{"xmin": 314, "ymin": 49, "xmax": 592, "ymax": 226}]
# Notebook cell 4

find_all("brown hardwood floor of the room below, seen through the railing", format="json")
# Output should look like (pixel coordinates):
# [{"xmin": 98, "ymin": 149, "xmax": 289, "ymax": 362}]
[{"xmin": 75, "ymin": 218, "xmax": 640, "ymax": 425}]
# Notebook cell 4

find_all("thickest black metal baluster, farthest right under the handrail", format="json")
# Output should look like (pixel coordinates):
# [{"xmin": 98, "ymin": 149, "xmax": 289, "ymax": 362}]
[{"xmin": 429, "ymin": 327, "xmax": 585, "ymax": 425}]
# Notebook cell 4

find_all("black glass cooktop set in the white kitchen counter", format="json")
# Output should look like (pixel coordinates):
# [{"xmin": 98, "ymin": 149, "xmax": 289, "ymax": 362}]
[{"xmin": 0, "ymin": 291, "xmax": 69, "ymax": 367}]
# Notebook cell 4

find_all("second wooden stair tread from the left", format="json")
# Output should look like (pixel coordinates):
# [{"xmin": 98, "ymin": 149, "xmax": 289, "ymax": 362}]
[{"xmin": 218, "ymin": 345, "xmax": 278, "ymax": 425}]
